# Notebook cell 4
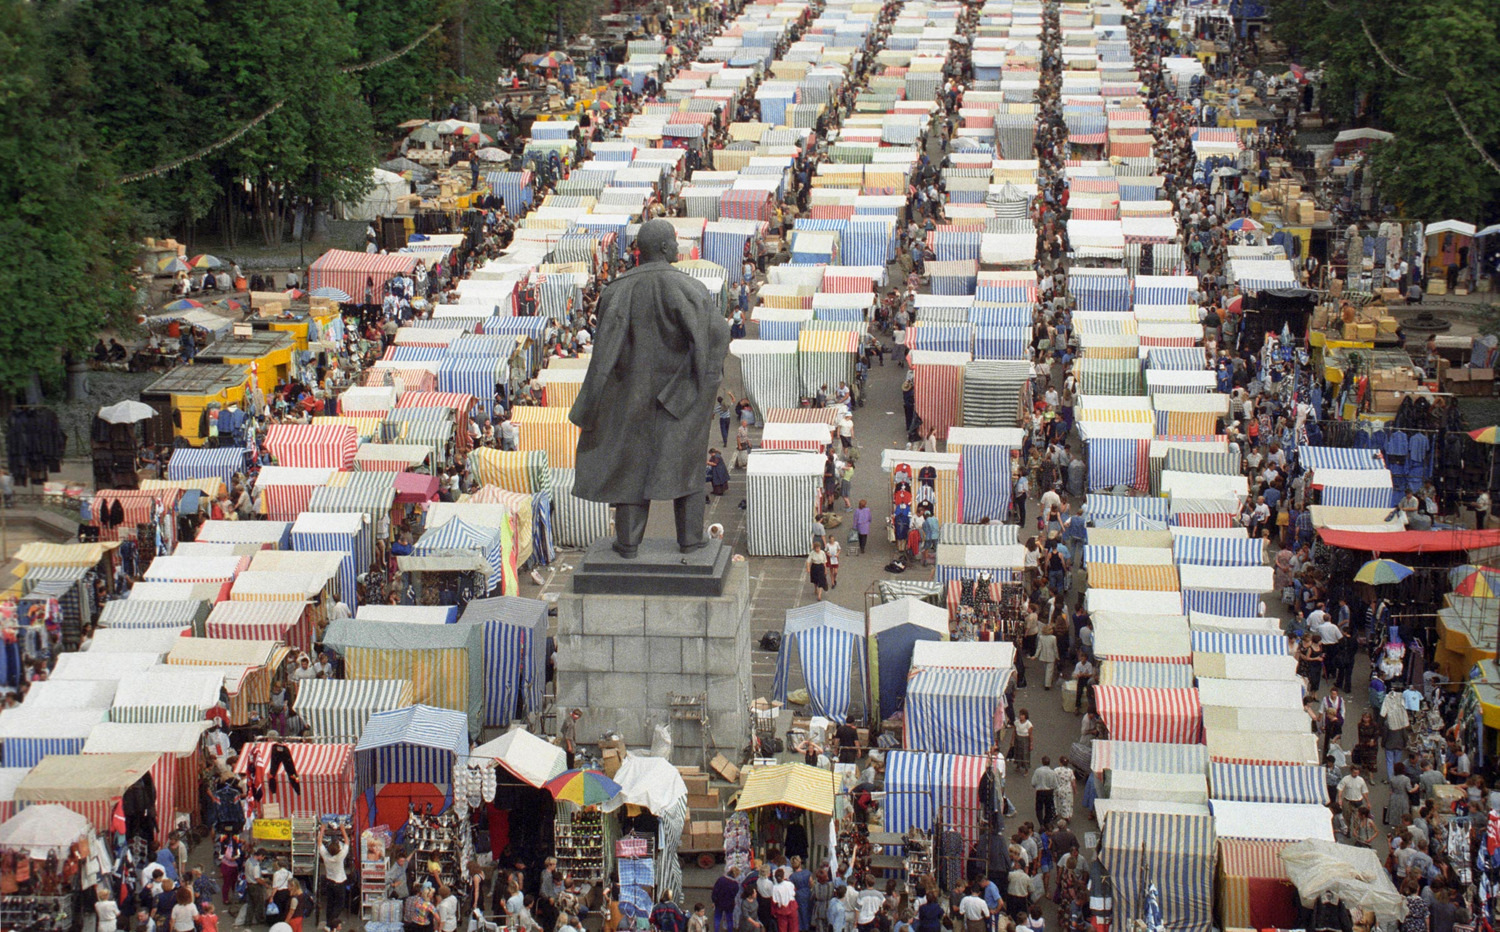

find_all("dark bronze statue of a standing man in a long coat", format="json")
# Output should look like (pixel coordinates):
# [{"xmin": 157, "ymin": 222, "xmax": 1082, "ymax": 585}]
[{"xmin": 569, "ymin": 219, "xmax": 729, "ymax": 558}]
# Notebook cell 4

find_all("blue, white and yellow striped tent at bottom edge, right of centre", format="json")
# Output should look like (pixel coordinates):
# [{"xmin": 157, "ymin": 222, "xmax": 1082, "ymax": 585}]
[{"xmin": 1100, "ymin": 810, "xmax": 1215, "ymax": 932}]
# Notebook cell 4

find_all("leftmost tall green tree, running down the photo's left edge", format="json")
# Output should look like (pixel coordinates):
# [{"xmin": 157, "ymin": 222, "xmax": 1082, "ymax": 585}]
[{"xmin": 0, "ymin": 3, "xmax": 134, "ymax": 392}]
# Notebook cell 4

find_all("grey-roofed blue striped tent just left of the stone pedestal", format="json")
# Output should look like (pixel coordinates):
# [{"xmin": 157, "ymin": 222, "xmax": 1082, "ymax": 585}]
[{"xmin": 459, "ymin": 596, "xmax": 548, "ymax": 726}]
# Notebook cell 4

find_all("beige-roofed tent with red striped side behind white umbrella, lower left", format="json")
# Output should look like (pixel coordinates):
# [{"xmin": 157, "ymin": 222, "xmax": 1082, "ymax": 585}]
[{"xmin": 15, "ymin": 752, "xmax": 177, "ymax": 843}]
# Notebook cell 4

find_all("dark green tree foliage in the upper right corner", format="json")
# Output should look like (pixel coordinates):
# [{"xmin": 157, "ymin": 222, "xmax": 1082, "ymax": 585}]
[{"xmin": 1272, "ymin": 0, "xmax": 1500, "ymax": 221}]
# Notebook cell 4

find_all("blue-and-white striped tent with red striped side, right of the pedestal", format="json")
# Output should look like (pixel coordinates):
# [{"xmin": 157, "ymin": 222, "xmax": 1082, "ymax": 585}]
[{"xmin": 882, "ymin": 750, "xmax": 1005, "ymax": 845}]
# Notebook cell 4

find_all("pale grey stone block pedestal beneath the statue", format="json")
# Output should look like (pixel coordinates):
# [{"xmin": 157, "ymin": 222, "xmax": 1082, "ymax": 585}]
[{"xmin": 557, "ymin": 563, "xmax": 752, "ymax": 764}]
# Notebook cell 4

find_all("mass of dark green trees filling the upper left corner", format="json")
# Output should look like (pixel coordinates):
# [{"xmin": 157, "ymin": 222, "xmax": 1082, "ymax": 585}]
[{"xmin": 0, "ymin": 0, "xmax": 599, "ymax": 392}]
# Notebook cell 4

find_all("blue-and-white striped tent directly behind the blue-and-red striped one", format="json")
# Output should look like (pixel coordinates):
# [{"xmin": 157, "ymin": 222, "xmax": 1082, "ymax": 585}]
[{"xmin": 905, "ymin": 666, "xmax": 1010, "ymax": 755}]
